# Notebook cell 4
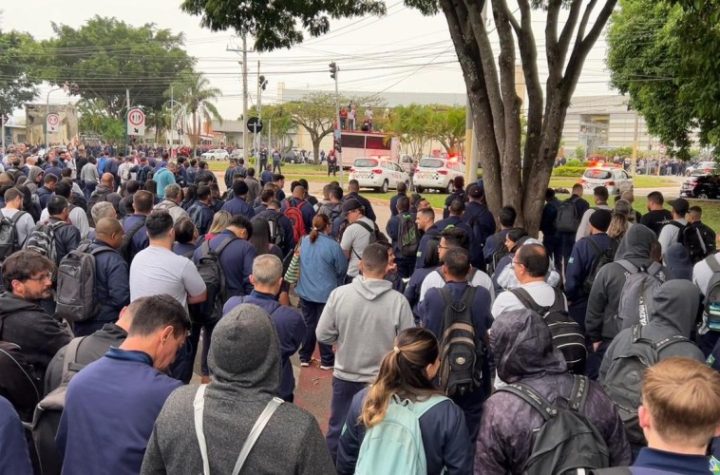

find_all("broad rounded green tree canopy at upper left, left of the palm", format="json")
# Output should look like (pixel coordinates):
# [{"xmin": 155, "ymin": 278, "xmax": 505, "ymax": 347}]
[{"xmin": 37, "ymin": 16, "xmax": 194, "ymax": 118}]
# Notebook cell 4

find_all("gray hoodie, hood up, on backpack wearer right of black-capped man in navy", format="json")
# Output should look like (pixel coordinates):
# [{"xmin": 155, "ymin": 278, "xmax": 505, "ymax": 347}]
[{"xmin": 585, "ymin": 224, "xmax": 657, "ymax": 342}]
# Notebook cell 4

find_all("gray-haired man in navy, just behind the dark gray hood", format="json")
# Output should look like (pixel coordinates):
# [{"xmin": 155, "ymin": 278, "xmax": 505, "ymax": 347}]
[{"xmin": 223, "ymin": 254, "xmax": 305, "ymax": 402}]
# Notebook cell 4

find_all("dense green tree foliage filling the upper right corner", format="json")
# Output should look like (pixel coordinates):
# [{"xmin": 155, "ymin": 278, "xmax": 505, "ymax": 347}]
[{"xmin": 608, "ymin": 0, "xmax": 720, "ymax": 158}]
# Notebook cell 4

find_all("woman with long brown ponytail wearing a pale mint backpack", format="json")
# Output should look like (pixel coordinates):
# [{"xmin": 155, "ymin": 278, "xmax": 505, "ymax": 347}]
[{"xmin": 337, "ymin": 328, "xmax": 473, "ymax": 475}]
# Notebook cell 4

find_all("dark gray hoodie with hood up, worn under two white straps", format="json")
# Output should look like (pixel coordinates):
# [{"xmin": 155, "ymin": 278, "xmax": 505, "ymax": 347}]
[{"xmin": 141, "ymin": 304, "xmax": 335, "ymax": 475}]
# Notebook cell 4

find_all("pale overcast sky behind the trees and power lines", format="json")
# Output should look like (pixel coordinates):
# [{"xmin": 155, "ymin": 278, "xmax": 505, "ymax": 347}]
[{"xmin": 0, "ymin": 0, "xmax": 610, "ymax": 119}]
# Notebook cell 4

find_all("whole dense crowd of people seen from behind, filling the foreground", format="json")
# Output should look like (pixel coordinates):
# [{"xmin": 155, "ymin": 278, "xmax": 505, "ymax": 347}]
[{"xmin": 0, "ymin": 145, "xmax": 720, "ymax": 475}]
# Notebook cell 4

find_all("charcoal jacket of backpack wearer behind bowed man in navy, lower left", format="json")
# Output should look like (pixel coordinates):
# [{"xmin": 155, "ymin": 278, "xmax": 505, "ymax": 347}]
[{"xmin": 45, "ymin": 323, "xmax": 127, "ymax": 394}]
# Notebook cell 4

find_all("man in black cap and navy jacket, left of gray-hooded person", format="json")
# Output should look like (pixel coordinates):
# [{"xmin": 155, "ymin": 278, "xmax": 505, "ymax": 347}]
[{"xmin": 565, "ymin": 209, "xmax": 617, "ymax": 328}]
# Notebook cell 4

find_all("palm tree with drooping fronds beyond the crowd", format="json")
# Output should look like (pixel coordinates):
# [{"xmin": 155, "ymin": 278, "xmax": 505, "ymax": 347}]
[{"xmin": 166, "ymin": 72, "xmax": 222, "ymax": 149}]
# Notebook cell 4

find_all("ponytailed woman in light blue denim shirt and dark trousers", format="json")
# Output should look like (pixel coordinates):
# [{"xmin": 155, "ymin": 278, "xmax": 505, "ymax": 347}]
[{"xmin": 295, "ymin": 214, "xmax": 348, "ymax": 369}]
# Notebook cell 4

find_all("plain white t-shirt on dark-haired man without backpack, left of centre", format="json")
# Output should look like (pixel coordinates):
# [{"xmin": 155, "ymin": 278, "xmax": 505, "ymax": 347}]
[{"xmin": 130, "ymin": 246, "xmax": 206, "ymax": 308}]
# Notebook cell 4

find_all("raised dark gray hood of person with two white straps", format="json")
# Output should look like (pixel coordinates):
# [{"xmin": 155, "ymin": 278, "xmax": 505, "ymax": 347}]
[{"xmin": 208, "ymin": 304, "xmax": 280, "ymax": 396}]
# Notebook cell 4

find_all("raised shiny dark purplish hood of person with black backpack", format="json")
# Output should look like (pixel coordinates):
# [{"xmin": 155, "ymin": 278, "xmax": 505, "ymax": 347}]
[{"xmin": 490, "ymin": 309, "xmax": 567, "ymax": 383}]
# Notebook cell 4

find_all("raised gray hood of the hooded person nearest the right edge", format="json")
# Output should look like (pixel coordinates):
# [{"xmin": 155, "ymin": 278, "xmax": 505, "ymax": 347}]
[{"xmin": 648, "ymin": 279, "xmax": 700, "ymax": 338}]
